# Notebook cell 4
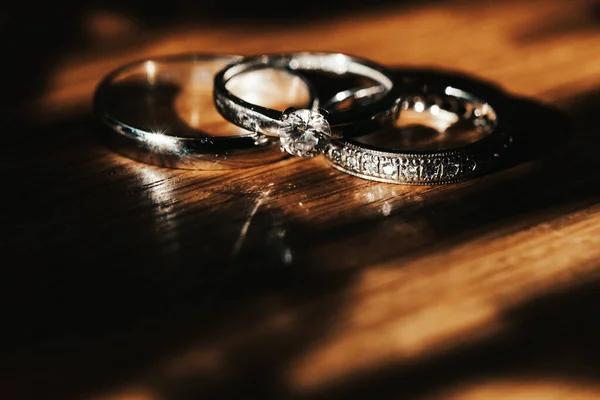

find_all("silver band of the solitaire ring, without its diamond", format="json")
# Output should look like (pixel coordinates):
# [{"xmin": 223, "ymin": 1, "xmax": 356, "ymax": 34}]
[{"xmin": 214, "ymin": 53, "xmax": 397, "ymax": 136}]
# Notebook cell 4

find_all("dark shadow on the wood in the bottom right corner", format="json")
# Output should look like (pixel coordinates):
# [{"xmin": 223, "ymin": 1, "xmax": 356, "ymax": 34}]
[{"xmin": 312, "ymin": 268, "xmax": 600, "ymax": 399}]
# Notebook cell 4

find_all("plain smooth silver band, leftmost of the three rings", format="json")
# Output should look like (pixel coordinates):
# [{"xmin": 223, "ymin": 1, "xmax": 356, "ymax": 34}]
[{"xmin": 94, "ymin": 54, "xmax": 315, "ymax": 170}]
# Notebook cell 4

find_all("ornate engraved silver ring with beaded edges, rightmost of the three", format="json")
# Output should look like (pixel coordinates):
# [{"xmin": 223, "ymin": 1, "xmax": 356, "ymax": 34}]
[{"xmin": 326, "ymin": 75, "xmax": 512, "ymax": 185}]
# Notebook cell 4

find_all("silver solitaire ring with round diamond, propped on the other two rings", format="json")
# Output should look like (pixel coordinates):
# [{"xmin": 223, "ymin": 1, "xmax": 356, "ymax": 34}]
[{"xmin": 214, "ymin": 53, "xmax": 397, "ymax": 157}]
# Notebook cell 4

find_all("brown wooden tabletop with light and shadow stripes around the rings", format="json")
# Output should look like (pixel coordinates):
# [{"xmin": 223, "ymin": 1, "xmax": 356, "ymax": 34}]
[{"xmin": 0, "ymin": 0, "xmax": 600, "ymax": 400}]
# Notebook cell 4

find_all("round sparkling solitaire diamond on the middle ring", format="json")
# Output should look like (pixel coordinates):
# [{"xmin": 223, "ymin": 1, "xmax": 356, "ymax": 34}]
[{"xmin": 279, "ymin": 109, "xmax": 331, "ymax": 158}]
